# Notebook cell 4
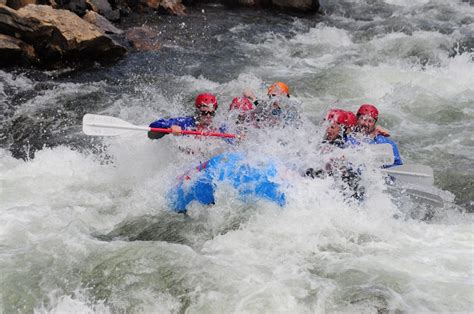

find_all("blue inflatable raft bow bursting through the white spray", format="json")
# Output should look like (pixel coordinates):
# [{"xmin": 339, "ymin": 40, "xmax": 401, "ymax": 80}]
[{"xmin": 168, "ymin": 153, "xmax": 286, "ymax": 213}]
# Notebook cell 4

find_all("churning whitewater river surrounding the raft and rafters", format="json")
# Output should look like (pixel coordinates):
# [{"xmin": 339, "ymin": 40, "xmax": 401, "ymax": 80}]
[{"xmin": 0, "ymin": 0, "xmax": 474, "ymax": 313}]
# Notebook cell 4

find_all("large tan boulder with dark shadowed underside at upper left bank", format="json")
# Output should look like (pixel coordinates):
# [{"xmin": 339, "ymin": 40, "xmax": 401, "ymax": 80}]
[{"xmin": 0, "ymin": 5, "xmax": 126, "ymax": 65}]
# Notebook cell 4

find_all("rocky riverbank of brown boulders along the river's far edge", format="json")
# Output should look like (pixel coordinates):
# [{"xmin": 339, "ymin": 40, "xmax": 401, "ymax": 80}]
[{"xmin": 0, "ymin": 0, "xmax": 319, "ymax": 68}]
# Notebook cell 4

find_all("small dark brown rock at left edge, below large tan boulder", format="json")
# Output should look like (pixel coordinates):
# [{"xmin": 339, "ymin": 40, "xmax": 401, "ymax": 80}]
[{"xmin": 0, "ymin": 34, "xmax": 38, "ymax": 66}]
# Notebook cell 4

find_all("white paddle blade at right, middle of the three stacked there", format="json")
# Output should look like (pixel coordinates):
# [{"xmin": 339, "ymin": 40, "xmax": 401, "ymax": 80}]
[{"xmin": 383, "ymin": 164, "xmax": 434, "ymax": 186}]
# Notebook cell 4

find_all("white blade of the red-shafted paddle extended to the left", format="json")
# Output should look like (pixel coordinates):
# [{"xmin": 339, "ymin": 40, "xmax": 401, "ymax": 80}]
[{"xmin": 82, "ymin": 113, "xmax": 150, "ymax": 136}]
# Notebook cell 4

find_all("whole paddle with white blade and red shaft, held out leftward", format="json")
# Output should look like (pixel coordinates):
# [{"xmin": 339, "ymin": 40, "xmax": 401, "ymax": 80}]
[{"xmin": 82, "ymin": 113, "xmax": 236, "ymax": 138}]
